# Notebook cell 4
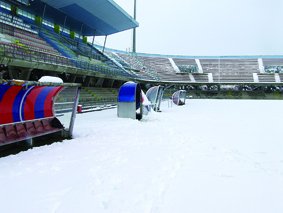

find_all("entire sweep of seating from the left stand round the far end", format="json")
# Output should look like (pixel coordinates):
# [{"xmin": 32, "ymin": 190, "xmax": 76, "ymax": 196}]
[{"xmin": 0, "ymin": 4, "xmax": 283, "ymax": 83}]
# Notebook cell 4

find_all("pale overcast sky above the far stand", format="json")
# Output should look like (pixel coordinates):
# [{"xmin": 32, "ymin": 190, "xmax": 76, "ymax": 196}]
[{"xmin": 95, "ymin": 0, "xmax": 283, "ymax": 56}]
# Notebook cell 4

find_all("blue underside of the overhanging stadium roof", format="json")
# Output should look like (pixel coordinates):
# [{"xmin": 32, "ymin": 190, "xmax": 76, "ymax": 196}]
[{"xmin": 19, "ymin": 0, "xmax": 139, "ymax": 36}]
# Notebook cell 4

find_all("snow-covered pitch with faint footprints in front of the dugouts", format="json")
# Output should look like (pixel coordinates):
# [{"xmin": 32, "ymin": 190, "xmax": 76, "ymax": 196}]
[{"xmin": 0, "ymin": 100, "xmax": 283, "ymax": 213}]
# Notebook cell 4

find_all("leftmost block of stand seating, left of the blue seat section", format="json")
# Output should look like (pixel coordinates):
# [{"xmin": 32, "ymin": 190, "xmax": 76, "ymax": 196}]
[{"xmin": 0, "ymin": 12, "xmax": 74, "ymax": 65}]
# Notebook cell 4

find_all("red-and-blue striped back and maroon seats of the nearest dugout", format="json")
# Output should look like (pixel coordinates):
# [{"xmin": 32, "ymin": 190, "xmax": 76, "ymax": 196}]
[{"xmin": 0, "ymin": 81, "xmax": 80, "ymax": 146}]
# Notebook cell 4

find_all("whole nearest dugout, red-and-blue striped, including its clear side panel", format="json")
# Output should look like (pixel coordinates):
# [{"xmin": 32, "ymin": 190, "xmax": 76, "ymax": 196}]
[{"xmin": 0, "ymin": 79, "xmax": 80, "ymax": 146}]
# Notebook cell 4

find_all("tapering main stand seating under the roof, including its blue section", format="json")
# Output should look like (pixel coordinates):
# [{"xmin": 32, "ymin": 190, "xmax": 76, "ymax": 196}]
[{"xmin": 0, "ymin": 8, "xmax": 131, "ymax": 77}]
